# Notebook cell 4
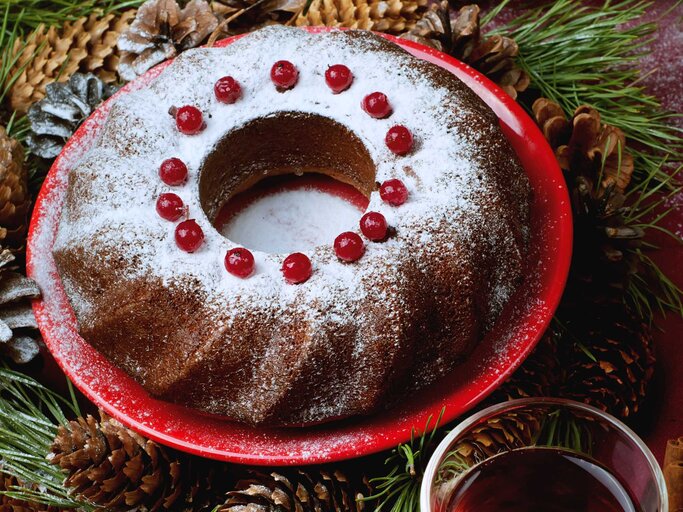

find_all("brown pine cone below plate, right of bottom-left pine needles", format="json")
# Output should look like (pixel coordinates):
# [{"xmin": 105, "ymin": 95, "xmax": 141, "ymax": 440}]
[{"xmin": 52, "ymin": 413, "xmax": 232, "ymax": 512}]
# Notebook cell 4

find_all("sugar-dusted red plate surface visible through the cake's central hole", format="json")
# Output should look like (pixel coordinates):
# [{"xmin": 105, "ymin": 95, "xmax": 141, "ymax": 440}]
[{"xmin": 214, "ymin": 173, "xmax": 368, "ymax": 253}]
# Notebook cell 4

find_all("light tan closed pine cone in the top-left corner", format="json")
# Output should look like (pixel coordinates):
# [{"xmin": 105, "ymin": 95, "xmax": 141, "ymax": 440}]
[{"xmin": 5, "ymin": 9, "xmax": 135, "ymax": 114}]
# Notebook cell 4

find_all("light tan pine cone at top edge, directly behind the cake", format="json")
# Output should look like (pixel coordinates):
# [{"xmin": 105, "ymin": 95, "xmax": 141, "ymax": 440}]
[{"xmin": 296, "ymin": 0, "xmax": 428, "ymax": 34}]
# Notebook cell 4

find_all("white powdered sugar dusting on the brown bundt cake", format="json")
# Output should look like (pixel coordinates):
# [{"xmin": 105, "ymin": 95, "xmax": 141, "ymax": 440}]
[{"xmin": 49, "ymin": 27, "xmax": 521, "ymax": 428}]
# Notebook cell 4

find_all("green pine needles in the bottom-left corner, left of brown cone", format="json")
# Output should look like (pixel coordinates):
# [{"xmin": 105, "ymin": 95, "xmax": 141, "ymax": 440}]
[{"xmin": 0, "ymin": 367, "xmax": 93, "ymax": 511}]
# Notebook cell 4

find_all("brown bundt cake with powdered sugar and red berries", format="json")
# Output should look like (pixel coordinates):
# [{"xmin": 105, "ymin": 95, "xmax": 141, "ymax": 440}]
[{"xmin": 53, "ymin": 26, "xmax": 529, "ymax": 425}]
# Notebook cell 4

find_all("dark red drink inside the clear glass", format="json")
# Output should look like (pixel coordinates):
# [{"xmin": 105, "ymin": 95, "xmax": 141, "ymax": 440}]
[{"xmin": 446, "ymin": 448, "xmax": 640, "ymax": 512}]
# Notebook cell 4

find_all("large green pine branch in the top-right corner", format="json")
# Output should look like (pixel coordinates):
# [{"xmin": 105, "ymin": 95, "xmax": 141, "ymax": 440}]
[{"xmin": 492, "ymin": 0, "xmax": 683, "ymax": 188}]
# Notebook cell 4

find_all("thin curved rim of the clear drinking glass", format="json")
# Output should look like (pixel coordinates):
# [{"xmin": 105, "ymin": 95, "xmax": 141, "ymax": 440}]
[{"xmin": 420, "ymin": 397, "xmax": 669, "ymax": 512}]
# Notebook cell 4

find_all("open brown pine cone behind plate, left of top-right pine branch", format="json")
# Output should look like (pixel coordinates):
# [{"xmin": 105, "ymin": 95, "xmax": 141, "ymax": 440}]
[{"xmin": 401, "ymin": 0, "xmax": 529, "ymax": 98}]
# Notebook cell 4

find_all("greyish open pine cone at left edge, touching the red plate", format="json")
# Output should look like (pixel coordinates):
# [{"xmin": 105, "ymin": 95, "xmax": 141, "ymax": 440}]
[{"xmin": 0, "ymin": 248, "xmax": 40, "ymax": 364}]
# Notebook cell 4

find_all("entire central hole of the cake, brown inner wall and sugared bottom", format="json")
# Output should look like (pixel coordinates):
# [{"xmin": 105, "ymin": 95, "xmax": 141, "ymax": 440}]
[{"xmin": 199, "ymin": 112, "xmax": 375, "ymax": 253}]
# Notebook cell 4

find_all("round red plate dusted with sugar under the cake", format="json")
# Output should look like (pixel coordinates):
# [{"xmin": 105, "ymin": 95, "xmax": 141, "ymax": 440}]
[{"xmin": 27, "ymin": 29, "xmax": 572, "ymax": 465}]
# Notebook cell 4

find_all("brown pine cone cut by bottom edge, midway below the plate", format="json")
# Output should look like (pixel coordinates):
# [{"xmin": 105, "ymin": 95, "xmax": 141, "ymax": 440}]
[{"xmin": 219, "ymin": 469, "xmax": 368, "ymax": 512}]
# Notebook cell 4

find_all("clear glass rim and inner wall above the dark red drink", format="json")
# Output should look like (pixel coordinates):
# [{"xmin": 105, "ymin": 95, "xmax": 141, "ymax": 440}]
[{"xmin": 420, "ymin": 398, "xmax": 669, "ymax": 512}]
